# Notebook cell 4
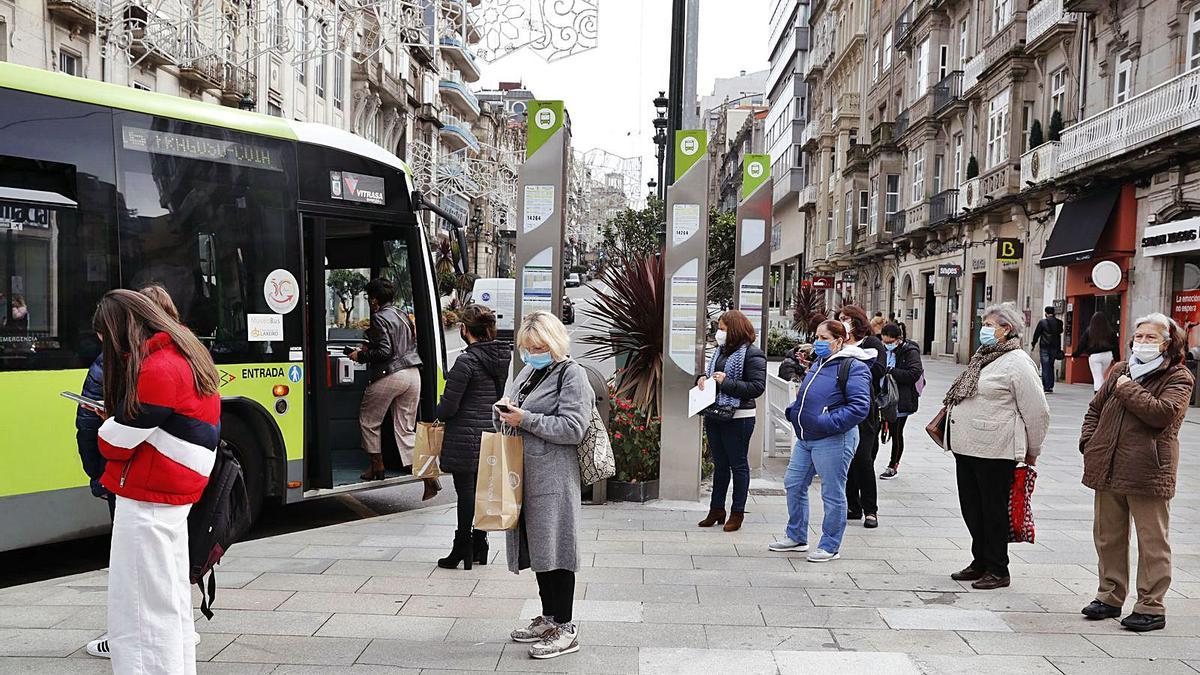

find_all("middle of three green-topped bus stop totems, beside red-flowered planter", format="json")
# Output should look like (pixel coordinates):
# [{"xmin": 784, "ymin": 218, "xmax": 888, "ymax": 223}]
[{"xmin": 659, "ymin": 131, "xmax": 708, "ymax": 501}]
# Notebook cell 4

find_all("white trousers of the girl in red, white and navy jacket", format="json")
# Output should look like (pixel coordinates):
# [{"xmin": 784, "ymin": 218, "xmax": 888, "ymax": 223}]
[{"xmin": 108, "ymin": 497, "xmax": 196, "ymax": 675}]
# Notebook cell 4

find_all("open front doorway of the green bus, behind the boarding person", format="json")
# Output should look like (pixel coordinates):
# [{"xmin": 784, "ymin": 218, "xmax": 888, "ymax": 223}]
[{"xmin": 304, "ymin": 215, "xmax": 414, "ymax": 491}]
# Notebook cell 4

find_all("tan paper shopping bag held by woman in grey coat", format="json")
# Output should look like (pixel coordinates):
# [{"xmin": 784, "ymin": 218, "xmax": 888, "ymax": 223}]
[{"xmin": 474, "ymin": 432, "xmax": 524, "ymax": 532}]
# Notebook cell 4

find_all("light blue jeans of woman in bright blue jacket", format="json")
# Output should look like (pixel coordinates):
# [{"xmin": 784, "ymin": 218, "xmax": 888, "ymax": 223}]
[{"xmin": 784, "ymin": 428, "xmax": 858, "ymax": 554}]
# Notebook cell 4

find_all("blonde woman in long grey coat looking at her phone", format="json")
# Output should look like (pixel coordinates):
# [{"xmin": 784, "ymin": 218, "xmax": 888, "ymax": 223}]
[{"xmin": 494, "ymin": 311, "xmax": 595, "ymax": 658}]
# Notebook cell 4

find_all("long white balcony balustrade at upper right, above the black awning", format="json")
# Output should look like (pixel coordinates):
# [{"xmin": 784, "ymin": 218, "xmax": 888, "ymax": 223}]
[{"xmin": 1058, "ymin": 63, "xmax": 1200, "ymax": 174}]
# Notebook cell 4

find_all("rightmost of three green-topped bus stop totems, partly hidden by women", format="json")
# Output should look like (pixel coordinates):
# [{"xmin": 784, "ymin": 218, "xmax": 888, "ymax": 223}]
[{"xmin": 733, "ymin": 155, "xmax": 773, "ymax": 474}]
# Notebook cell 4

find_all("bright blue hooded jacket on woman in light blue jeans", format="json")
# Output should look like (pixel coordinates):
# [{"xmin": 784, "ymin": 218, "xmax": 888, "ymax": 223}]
[{"xmin": 786, "ymin": 347, "xmax": 871, "ymax": 441}]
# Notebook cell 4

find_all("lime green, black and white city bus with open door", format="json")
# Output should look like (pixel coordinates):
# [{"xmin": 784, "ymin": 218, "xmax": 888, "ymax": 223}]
[{"xmin": 0, "ymin": 64, "xmax": 458, "ymax": 550}]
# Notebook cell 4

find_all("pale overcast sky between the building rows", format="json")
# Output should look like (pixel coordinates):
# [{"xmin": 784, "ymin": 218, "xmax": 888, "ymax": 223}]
[{"xmin": 479, "ymin": 0, "xmax": 768, "ymax": 196}]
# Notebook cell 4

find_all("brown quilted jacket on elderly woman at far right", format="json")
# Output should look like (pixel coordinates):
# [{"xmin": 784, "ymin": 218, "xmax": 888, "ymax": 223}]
[{"xmin": 1079, "ymin": 363, "xmax": 1193, "ymax": 498}]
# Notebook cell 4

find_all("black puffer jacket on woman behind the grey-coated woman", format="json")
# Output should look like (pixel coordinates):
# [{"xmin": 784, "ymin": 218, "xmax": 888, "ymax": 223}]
[{"xmin": 433, "ymin": 341, "xmax": 512, "ymax": 473}]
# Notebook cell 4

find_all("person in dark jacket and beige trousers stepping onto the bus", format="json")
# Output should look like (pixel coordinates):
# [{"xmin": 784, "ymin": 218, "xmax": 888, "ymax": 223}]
[{"xmin": 349, "ymin": 279, "xmax": 440, "ymax": 500}]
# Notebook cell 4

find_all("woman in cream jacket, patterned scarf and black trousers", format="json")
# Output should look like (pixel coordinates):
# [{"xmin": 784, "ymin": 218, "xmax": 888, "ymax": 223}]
[{"xmin": 942, "ymin": 303, "xmax": 1050, "ymax": 590}]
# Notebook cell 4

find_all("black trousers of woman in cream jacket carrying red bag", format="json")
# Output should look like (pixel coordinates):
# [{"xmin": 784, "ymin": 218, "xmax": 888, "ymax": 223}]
[{"xmin": 954, "ymin": 453, "xmax": 1016, "ymax": 577}]
